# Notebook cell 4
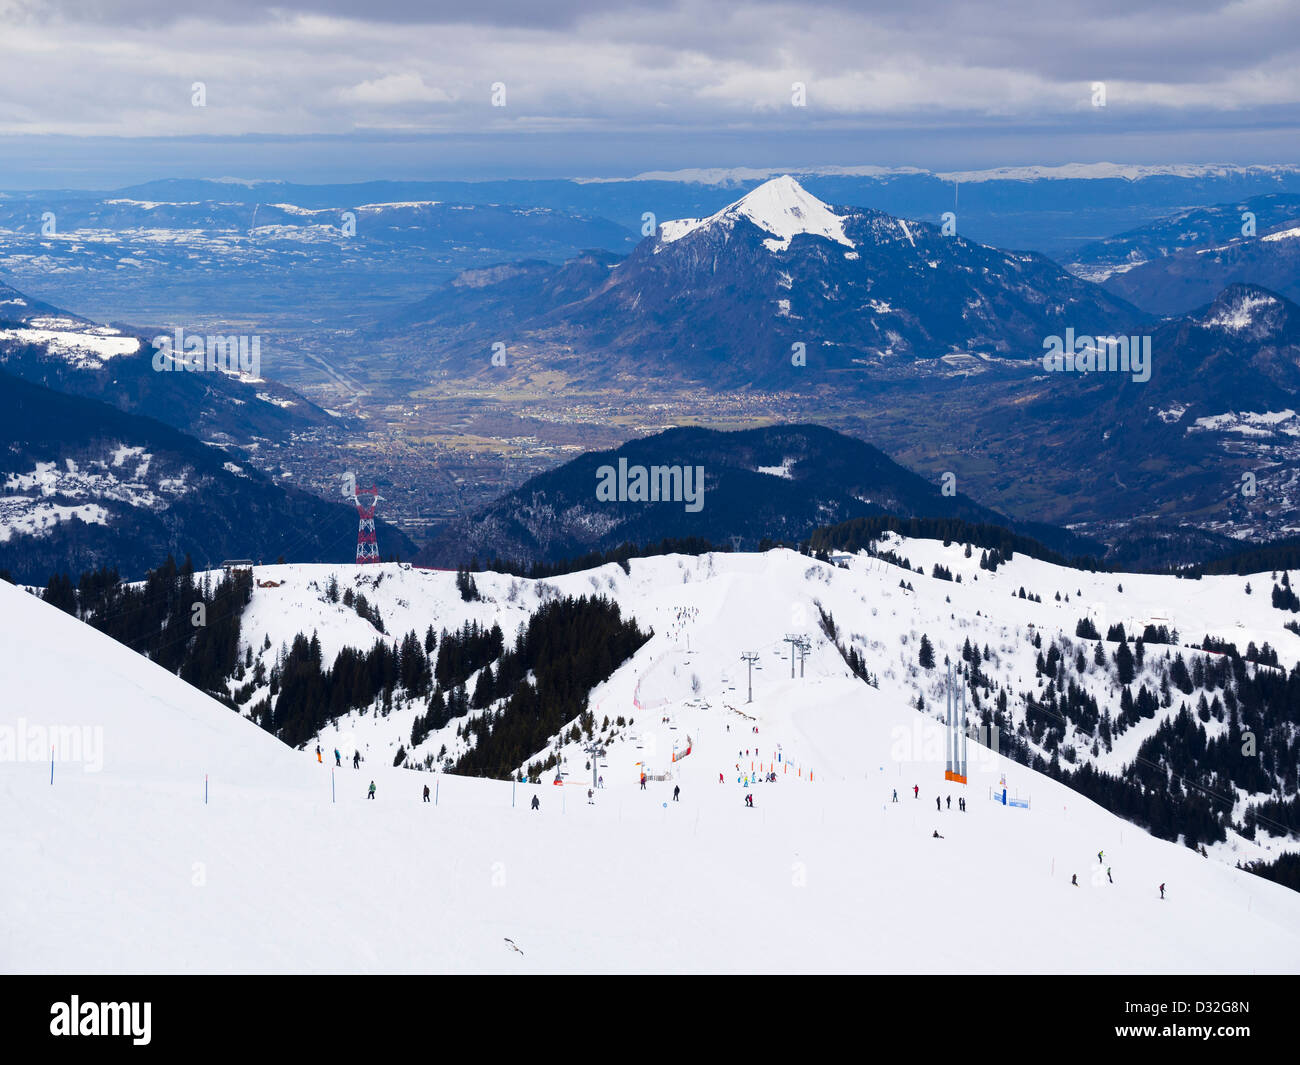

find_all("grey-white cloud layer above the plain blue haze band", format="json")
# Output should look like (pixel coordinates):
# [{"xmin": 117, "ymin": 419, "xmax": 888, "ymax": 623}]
[{"xmin": 0, "ymin": 0, "xmax": 1300, "ymax": 180}]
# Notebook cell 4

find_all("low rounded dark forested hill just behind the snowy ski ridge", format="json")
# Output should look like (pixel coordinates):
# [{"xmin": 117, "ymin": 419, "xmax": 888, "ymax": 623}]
[{"xmin": 417, "ymin": 425, "xmax": 1104, "ymax": 566}]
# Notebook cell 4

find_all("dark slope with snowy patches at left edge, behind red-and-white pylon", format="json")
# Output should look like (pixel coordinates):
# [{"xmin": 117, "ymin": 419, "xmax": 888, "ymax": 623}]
[{"xmin": 0, "ymin": 372, "xmax": 413, "ymax": 584}]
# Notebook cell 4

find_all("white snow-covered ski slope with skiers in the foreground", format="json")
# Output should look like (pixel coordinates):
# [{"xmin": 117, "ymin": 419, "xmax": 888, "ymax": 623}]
[{"xmin": 0, "ymin": 541, "xmax": 1300, "ymax": 977}]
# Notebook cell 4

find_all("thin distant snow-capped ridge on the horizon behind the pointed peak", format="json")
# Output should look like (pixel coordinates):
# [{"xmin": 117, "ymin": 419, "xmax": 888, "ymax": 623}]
[{"xmin": 587, "ymin": 163, "xmax": 1300, "ymax": 186}]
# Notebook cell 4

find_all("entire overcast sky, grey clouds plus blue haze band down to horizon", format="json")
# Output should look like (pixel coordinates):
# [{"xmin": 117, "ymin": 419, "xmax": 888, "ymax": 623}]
[{"xmin": 0, "ymin": 0, "xmax": 1300, "ymax": 187}]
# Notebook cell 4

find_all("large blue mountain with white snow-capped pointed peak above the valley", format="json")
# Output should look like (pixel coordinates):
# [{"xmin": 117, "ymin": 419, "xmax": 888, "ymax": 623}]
[{"xmin": 380, "ymin": 177, "xmax": 1145, "ymax": 389}]
